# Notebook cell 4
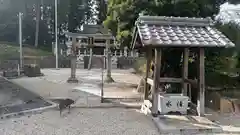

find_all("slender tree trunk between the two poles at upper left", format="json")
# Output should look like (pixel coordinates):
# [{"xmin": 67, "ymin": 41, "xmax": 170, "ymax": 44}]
[{"xmin": 34, "ymin": 1, "xmax": 41, "ymax": 47}]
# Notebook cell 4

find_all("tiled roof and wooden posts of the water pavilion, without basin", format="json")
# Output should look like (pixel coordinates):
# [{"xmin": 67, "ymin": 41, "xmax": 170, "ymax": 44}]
[{"xmin": 132, "ymin": 16, "xmax": 235, "ymax": 117}]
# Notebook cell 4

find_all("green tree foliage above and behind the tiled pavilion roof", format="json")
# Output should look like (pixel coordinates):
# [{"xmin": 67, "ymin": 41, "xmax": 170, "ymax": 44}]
[{"xmin": 104, "ymin": 0, "xmax": 240, "ymax": 87}]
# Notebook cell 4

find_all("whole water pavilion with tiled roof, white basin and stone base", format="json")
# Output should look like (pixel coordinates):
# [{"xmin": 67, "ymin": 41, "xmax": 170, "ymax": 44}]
[{"xmin": 132, "ymin": 16, "xmax": 235, "ymax": 134}]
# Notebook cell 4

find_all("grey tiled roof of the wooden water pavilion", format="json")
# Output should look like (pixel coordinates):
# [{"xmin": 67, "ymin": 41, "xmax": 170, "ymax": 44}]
[{"xmin": 132, "ymin": 16, "xmax": 234, "ymax": 47}]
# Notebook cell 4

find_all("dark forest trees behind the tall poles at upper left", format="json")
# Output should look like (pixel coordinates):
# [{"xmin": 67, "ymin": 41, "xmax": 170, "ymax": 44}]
[{"xmin": 0, "ymin": 0, "xmax": 94, "ymax": 48}]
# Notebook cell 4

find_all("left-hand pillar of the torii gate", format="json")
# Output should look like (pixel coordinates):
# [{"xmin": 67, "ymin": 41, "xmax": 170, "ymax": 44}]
[{"xmin": 67, "ymin": 37, "xmax": 78, "ymax": 83}]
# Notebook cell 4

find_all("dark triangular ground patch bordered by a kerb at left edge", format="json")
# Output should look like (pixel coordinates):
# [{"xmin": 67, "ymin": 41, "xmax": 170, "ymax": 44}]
[{"xmin": 0, "ymin": 77, "xmax": 52, "ymax": 116}]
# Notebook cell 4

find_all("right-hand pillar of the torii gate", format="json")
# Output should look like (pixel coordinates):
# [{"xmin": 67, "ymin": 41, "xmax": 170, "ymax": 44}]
[{"xmin": 105, "ymin": 39, "xmax": 114, "ymax": 83}]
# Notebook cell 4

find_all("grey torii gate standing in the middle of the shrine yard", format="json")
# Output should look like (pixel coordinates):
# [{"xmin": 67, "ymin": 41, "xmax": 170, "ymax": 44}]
[{"xmin": 66, "ymin": 25, "xmax": 115, "ymax": 83}]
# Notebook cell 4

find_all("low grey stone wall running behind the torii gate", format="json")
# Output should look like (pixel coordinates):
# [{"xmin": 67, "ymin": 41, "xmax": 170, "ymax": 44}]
[{"xmin": 0, "ymin": 56, "xmax": 141, "ymax": 70}]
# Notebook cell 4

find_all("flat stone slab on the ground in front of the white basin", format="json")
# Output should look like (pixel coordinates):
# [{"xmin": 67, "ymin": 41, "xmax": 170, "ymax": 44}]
[{"xmin": 153, "ymin": 115, "xmax": 223, "ymax": 135}]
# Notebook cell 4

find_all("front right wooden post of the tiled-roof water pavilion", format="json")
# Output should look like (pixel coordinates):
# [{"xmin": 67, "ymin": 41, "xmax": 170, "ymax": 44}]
[{"xmin": 197, "ymin": 48, "xmax": 205, "ymax": 116}]
